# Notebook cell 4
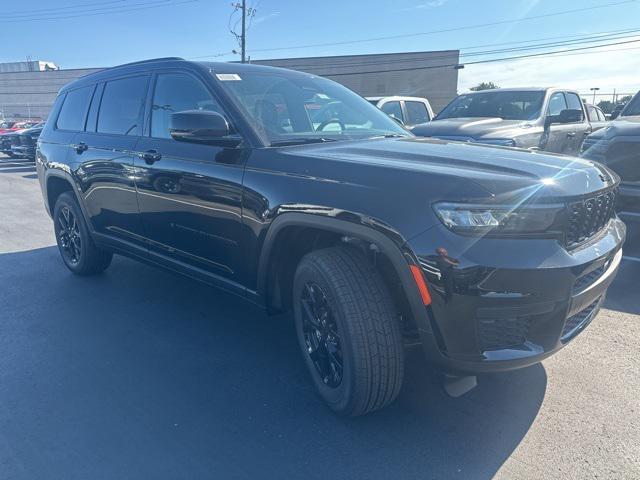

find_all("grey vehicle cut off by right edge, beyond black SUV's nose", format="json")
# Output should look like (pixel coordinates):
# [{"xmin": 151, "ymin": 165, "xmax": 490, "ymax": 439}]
[{"xmin": 582, "ymin": 92, "xmax": 640, "ymax": 213}]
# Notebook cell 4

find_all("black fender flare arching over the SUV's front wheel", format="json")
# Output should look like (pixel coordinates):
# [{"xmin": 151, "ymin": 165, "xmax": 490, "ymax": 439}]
[{"xmin": 257, "ymin": 212, "xmax": 429, "ymax": 328}]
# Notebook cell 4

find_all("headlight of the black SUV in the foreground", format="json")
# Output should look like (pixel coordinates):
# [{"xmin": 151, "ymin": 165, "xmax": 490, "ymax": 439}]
[{"xmin": 433, "ymin": 203, "xmax": 564, "ymax": 235}]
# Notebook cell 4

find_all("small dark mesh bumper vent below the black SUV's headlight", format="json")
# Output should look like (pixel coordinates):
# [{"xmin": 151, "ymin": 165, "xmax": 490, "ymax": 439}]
[{"xmin": 478, "ymin": 316, "xmax": 531, "ymax": 352}]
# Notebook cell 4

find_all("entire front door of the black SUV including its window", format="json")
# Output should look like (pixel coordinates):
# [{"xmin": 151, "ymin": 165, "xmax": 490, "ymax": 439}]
[{"xmin": 134, "ymin": 70, "xmax": 244, "ymax": 279}]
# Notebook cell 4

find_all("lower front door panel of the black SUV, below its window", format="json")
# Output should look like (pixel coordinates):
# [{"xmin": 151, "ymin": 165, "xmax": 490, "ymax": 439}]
[{"xmin": 134, "ymin": 138, "xmax": 244, "ymax": 278}]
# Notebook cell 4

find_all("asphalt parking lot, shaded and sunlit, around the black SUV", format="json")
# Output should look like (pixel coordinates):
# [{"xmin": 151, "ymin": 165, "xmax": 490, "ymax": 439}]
[{"xmin": 0, "ymin": 157, "xmax": 640, "ymax": 480}]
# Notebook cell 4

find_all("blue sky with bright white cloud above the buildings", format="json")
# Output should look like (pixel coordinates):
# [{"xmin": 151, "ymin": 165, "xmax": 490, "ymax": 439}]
[{"xmin": 0, "ymin": 0, "xmax": 640, "ymax": 96}]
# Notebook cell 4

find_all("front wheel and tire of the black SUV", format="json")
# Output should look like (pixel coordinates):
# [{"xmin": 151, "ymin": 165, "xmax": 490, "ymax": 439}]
[{"xmin": 293, "ymin": 247, "xmax": 404, "ymax": 416}]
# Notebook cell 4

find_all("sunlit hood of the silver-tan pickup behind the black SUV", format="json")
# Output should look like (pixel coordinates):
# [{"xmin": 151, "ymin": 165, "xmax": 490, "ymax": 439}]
[{"xmin": 411, "ymin": 117, "xmax": 531, "ymax": 141}]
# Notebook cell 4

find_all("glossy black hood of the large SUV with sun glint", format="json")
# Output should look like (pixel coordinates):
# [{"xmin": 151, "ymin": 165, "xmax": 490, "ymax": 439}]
[{"xmin": 282, "ymin": 137, "xmax": 619, "ymax": 200}]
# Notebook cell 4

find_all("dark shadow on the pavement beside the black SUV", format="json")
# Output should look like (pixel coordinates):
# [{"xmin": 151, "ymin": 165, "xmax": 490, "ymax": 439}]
[{"xmin": 0, "ymin": 247, "xmax": 547, "ymax": 479}]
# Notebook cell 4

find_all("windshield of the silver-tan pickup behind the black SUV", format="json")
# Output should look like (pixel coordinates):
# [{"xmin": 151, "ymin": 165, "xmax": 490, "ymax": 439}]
[{"xmin": 436, "ymin": 90, "xmax": 544, "ymax": 120}]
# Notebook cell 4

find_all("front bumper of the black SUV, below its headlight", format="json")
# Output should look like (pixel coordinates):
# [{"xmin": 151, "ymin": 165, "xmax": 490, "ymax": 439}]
[{"xmin": 407, "ymin": 218, "xmax": 626, "ymax": 374}]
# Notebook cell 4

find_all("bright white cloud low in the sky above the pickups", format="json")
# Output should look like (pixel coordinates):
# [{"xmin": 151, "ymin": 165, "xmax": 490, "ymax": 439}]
[{"xmin": 458, "ymin": 36, "xmax": 640, "ymax": 100}]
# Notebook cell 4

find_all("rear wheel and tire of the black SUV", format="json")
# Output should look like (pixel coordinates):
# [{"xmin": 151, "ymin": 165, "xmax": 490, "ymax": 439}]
[{"xmin": 53, "ymin": 192, "xmax": 113, "ymax": 275}]
